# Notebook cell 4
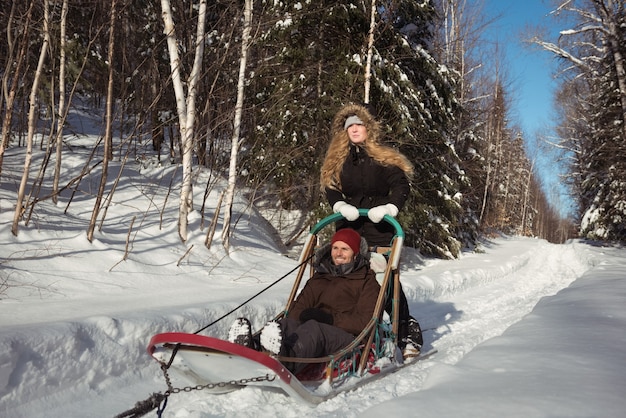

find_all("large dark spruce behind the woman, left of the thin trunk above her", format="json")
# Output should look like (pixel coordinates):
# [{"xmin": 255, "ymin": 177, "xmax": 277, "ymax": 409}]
[{"xmin": 242, "ymin": 1, "xmax": 369, "ymax": 210}]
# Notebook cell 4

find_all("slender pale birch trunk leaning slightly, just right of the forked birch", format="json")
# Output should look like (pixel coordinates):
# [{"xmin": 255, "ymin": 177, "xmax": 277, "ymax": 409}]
[{"xmin": 222, "ymin": 0, "xmax": 252, "ymax": 252}]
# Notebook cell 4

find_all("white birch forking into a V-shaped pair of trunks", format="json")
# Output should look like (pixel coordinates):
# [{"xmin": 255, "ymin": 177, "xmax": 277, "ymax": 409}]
[{"xmin": 161, "ymin": 0, "xmax": 206, "ymax": 242}]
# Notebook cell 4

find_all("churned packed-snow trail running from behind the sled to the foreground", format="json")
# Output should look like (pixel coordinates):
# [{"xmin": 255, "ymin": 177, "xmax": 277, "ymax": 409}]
[{"xmin": 124, "ymin": 238, "xmax": 590, "ymax": 417}]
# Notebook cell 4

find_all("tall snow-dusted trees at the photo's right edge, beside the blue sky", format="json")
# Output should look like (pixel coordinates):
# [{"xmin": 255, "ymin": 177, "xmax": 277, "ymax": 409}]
[{"xmin": 535, "ymin": 0, "xmax": 626, "ymax": 241}]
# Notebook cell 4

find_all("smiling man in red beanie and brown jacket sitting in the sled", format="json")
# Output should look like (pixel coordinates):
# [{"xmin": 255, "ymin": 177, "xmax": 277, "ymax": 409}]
[{"xmin": 228, "ymin": 228, "xmax": 380, "ymax": 373}]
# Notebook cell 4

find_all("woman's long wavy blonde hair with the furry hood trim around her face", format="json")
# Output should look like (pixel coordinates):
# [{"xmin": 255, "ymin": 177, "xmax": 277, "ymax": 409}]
[{"xmin": 320, "ymin": 104, "xmax": 413, "ymax": 191}]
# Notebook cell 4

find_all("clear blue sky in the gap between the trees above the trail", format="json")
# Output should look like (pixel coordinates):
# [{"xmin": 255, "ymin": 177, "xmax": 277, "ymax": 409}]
[{"xmin": 477, "ymin": 0, "xmax": 571, "ymax": 216}]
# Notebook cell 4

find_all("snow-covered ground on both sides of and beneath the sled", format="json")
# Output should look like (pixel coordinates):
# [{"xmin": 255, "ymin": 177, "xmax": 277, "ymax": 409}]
[{"xmin": 0, "ymin": 132, "xmax": 626, "ymax": 418}]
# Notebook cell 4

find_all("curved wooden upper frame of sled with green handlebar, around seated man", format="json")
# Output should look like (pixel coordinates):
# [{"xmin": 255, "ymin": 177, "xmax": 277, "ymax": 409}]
[{"xmin": 276, "ymin": 209, "xmax": 404, "ymax": 382}]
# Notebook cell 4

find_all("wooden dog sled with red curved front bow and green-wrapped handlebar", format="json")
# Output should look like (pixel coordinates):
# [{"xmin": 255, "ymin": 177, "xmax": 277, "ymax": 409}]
[{"xmin": 148, "ymin": 209, "xmax": 434, "ymax": 405}]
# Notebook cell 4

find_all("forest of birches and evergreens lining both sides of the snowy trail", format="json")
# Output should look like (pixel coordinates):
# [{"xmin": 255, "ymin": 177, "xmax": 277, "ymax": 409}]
[{"xmin": 0, "ymin": 0, "xmax": 626, "ymax": 257}]
